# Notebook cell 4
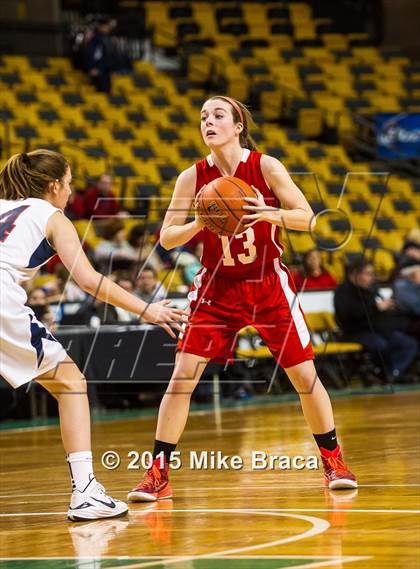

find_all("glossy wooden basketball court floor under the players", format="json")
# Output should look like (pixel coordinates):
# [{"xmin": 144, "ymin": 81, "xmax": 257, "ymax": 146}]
[{"xmin": 0, "ymin": 392, "xmax": 420, "ymax": 569}]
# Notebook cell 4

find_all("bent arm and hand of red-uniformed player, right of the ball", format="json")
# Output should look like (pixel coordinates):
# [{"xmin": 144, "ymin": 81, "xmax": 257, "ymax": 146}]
[{"xmin": 243, "ymin": 154, "xmax": 315, "ymax": 231}]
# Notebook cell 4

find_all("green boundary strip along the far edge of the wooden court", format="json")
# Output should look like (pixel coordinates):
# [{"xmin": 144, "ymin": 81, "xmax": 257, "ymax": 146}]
[{"xmin": 0, "ymin": 383, "xmax": 420, "ymax": 430}]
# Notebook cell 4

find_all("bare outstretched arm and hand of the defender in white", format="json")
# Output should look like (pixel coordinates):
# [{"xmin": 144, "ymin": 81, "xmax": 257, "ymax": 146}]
[{"xmin": 46, "ymin": 212, "xmax": 187, "ymax": 337}]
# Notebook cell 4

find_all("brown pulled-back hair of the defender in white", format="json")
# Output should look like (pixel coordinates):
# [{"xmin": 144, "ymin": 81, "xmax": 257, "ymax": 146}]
[{"xmin": 0, "ymin": 149, "xmax": 68, "ymax": 200}]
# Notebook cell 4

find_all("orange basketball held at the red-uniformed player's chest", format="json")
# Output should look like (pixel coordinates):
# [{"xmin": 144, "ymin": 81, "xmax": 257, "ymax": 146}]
[{"xmin": 197, "ymin": 176, "xmax": 255, "ymax": 235}]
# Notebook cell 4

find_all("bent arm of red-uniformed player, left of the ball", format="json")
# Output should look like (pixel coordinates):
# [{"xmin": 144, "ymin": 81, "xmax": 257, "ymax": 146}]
[{"xmin": 160, "ymin": 165, "xmax": 204, "ymax": 249}]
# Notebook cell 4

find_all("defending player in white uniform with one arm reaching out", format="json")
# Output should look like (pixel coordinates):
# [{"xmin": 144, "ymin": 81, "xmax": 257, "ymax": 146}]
[{"xmin": 0, "ymin": 150, "xmax": 187, "ymax": 521}]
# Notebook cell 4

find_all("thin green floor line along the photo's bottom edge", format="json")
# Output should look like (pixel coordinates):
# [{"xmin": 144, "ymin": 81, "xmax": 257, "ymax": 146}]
[{"xmin": 0, "ymin": 556, "xmax": 318, "ymax": 569}]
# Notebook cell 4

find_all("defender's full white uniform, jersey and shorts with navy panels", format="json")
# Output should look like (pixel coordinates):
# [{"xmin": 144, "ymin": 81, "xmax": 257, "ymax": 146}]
[{"xmin": 0, "ymin": 198, "xmax": 66, "ymax": 387}]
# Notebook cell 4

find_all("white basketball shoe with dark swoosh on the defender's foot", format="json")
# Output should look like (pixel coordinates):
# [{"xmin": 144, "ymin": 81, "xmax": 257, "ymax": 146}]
[{"xmin": 67, "ymin": 478, "xmax": 128, "ymax": 522}]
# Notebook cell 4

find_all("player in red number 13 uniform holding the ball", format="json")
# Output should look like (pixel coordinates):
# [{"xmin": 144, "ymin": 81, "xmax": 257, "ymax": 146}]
[{"xmin": 128, "ymin": 96, "xmax": 357, "ymax": 501}]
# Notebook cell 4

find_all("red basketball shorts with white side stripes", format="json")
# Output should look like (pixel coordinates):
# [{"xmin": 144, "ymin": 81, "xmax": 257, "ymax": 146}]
[{"xmin": 177, "ymin": 259, "xmax": 314, "ymax": 368}]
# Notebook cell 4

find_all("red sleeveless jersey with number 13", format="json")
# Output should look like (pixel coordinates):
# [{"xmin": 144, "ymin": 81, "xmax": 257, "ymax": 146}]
[{"xmin": 195, "ymin": 148, "xmax": 284, "ymax": 279}]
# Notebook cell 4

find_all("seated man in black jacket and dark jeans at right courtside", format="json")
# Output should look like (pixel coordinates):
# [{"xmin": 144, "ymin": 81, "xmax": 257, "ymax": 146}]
[{"xmin": 334, "ymin": 259, "xmax": 418, "ymax": 381}]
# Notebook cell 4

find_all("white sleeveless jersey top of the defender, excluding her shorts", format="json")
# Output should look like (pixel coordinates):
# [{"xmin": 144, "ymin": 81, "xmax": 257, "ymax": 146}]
[{"xmin": 0, "ymin": 198, "xmax": 61, "ymax": 283}]
